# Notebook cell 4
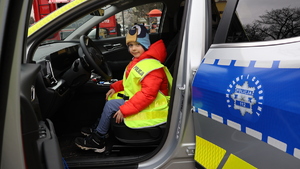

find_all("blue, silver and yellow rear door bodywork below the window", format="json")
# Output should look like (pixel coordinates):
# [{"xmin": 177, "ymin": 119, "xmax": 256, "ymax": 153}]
[{"xmin": 193, "ymin": 40, "xmax": 300, "ymax": 168}]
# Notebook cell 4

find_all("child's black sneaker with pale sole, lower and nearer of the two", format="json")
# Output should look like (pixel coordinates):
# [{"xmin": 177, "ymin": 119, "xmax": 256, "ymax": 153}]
[{"xmin": 75, "ymin": 131, "xmax": 106, "ymax": 153}]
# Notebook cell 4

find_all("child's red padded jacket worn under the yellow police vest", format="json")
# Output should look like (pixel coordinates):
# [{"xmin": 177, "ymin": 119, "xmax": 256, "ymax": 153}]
[{"xmin": 111, "ymin": 40, "xmax": 168, "ymax": 117}]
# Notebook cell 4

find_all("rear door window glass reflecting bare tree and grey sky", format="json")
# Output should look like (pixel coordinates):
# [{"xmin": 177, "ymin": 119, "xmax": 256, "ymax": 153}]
[{"xmin": 237, "ymin": 0, "xmax": 300, "ymax": 41}]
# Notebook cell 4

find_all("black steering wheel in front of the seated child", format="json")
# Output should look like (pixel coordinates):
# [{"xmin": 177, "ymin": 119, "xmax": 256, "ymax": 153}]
[{"xmin": 79, "ymin": 35, "xmax": 112, "ymax": 80}]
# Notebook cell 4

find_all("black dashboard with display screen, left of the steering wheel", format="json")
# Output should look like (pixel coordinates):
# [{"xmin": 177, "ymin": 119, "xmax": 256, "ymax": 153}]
[{"xmin": 33, "ymin": 42, "xmax": 91, "ymax": 117}]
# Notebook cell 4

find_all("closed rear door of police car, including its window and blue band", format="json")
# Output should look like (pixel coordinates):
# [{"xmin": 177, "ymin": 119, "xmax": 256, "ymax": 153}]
[{"xmin": 192, "ymin": 0, "xmax": 300, "ymax": 169}]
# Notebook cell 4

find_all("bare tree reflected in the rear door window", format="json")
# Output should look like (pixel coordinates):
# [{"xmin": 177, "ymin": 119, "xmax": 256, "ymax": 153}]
[{"xmin": 244, "ymin": 8, "xmax": 300, "ymax": 41}]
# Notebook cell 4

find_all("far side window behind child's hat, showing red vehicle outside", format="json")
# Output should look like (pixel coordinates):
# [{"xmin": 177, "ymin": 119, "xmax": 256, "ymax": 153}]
[{"xmin": 100, "ymin": 2, "xmax": 163, "ymax": 38}]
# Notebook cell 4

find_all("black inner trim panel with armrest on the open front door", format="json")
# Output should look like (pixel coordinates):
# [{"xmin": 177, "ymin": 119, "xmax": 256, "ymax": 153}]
[{"xmin": 20, "ymin": 64, "xmax": 63, "ymax": 169}]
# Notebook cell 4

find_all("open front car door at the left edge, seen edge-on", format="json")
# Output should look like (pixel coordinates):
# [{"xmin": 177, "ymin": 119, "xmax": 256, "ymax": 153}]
[{"xmin": 0, "ymin": 0, "xmax": 63, "ymax": 169}]
